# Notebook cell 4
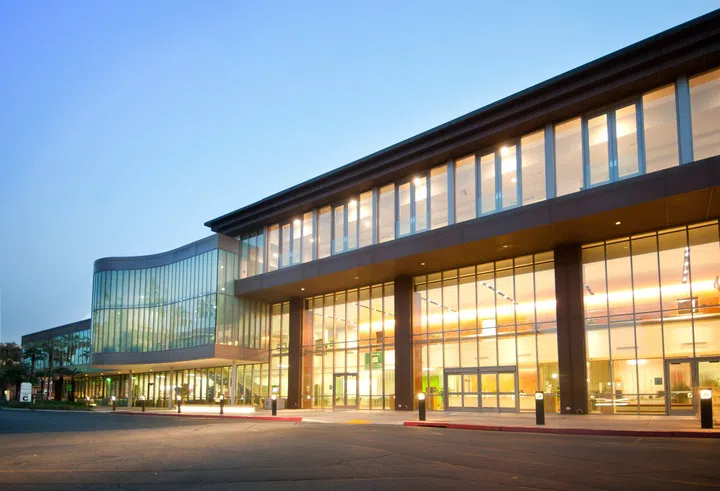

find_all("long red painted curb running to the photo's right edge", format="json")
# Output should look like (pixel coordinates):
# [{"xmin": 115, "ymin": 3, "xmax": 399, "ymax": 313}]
[{"xmin": 403, "ymin": 421, "xmax": 720, "ymax": 438}]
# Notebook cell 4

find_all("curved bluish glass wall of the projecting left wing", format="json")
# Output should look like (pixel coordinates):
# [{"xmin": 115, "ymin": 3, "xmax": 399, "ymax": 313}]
[{"xmin": 92, "ymin": 249, "xmax": 218, "ymax": 353}]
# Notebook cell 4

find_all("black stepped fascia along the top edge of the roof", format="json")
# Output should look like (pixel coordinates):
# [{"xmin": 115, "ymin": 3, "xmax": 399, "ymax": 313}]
[{"xmin": 205, "ymin": 9, "xmax": 720, "ymax": 236}]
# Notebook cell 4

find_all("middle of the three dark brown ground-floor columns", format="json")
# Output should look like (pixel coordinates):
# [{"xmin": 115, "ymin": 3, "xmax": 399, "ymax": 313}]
[{"xmin": 395, "ymin": 276, "xmax": 415, "ymax": 411}]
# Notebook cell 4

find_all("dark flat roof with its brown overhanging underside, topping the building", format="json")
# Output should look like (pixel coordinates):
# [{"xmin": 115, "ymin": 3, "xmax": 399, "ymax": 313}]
[{"xmin": 205, "ymin": 9, "xmax": 720, "ymax": 236}]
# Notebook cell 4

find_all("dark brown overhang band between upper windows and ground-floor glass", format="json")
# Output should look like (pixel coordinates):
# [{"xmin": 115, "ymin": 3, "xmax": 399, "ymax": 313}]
[{"xmin": 234, "ymin": 156, "xmax": 720, "ymax": 302}]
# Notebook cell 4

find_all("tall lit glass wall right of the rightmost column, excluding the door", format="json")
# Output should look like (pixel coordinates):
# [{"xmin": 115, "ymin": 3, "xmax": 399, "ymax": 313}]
[{"xmin": 583, "ymin": 222, "xmax": 720, "ymax": 414}]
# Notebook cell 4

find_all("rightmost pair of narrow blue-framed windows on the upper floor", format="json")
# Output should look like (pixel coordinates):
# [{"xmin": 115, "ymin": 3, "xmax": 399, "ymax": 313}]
[{"xmin": 582, "ymin": 103, "xmax": 644, "ymax": 187}]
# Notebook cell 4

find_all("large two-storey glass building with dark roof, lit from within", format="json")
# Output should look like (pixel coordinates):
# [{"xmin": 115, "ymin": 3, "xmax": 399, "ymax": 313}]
[{"xmin": 19, "ymin": 10, "xmax": 720, "ymax": 415}]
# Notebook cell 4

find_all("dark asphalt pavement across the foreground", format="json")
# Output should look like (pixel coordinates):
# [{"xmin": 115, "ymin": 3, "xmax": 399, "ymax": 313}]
[{"xmin": 0, "ymin": 410, "xmax": 720, "ymax": 491}]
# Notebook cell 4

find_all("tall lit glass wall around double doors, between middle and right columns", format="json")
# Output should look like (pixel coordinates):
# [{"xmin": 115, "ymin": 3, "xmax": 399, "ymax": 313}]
[{"xmin": 413, "ymin": 252, "xmax": 559, "ymax": 411}]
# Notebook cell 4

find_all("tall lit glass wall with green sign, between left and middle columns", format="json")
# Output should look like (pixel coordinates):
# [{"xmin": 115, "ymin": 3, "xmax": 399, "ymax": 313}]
[{"xmin": 302, "ymin": 283, "xmax": 395, "ymax": 409}]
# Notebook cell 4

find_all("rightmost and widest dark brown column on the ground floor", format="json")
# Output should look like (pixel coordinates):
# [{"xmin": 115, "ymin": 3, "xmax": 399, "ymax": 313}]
[{"xmin": 555, "ymin": 245, "xmax": 588, "ymax": 414}]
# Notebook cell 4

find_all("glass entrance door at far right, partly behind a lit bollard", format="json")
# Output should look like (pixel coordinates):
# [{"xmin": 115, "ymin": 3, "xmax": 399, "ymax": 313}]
[{"xmin": 665, "ymin": 358, "xmax": 720, "ymax": 416}]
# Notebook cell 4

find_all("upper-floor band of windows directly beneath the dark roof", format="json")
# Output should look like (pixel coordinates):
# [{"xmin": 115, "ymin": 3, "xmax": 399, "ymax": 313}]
[{"xmin": 236, "ymin": 69, "xmax": 720, "ymax": 278}]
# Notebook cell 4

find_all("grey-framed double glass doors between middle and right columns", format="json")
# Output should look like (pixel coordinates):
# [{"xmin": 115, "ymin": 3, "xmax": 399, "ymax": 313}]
[{"xmin": 445, "ymin": 367, "xmax": 518, "ymax": 412}]
